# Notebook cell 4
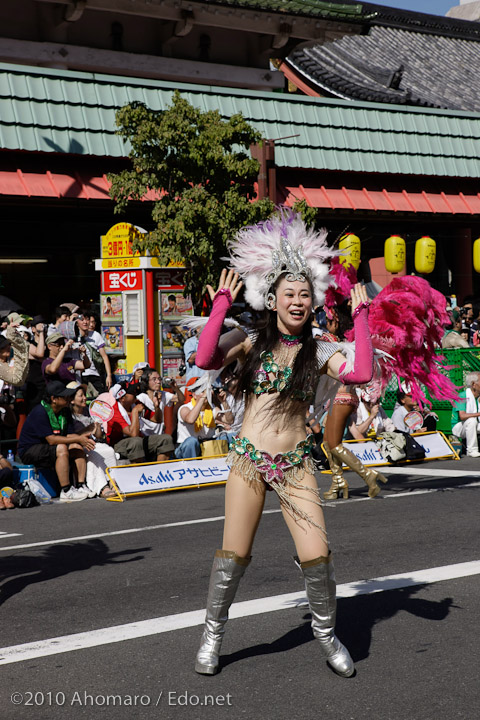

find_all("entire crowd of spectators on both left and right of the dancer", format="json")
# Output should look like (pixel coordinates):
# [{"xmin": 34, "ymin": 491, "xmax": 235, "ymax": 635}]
[{"xmin": 0, "ymin": 298, "xmax": 480, "ymax": 509}]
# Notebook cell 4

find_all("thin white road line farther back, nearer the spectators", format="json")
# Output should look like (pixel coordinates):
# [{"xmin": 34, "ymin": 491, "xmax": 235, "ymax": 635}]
[{"xmin": 0, "ymin": 476, "xmax": 480, "ymax": 552}]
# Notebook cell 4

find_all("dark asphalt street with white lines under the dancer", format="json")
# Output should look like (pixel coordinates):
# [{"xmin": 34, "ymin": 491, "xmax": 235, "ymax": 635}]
[{"xmin": 0, "ymin": 458, "xmax": 480, "ymax": 720}]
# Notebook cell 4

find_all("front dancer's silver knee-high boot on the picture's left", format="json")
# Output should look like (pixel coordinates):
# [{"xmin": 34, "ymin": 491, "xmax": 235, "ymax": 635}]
[{"xmin": 195, "ymin": 550, "xmax": 251, "ymax": 675}]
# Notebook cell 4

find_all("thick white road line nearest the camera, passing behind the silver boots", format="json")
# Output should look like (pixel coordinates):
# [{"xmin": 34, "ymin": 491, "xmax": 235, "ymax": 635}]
[{"xmin": 0, "ymin": 561, "xmax": 480, "ymax": 665}]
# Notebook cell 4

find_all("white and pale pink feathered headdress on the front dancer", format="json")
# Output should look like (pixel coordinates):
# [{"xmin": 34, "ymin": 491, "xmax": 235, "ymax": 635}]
[{"xmin": 227, "ymin": 208, "xmax": 336, "ymax": 310}]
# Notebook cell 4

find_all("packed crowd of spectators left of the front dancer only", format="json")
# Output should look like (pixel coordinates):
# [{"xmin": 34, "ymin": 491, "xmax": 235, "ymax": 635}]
[{"xmin": 0, "ymin": 304, "xmax": 243, "ymax": 509}]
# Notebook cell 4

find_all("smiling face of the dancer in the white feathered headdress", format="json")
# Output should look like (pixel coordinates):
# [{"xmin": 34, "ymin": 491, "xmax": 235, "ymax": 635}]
[{"xmin": 275, "ymin": 277, "xmax": 313, "ymax": 335}]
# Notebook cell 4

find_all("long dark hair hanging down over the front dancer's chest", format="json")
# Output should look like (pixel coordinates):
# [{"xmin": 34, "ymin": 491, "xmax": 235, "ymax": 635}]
[{"xmin": 235, "ymin": 310, "xmax": 320, "ymax": 412}]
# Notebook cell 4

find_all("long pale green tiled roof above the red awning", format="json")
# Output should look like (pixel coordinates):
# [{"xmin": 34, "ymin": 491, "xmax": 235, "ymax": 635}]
[{"xmin": 0, "ymin": 64, "xmax": 480, "ymax": 178}]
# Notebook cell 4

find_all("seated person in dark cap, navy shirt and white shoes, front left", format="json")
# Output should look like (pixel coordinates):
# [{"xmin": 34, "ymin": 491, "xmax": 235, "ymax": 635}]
[{"xmin": 18, "ymin": 380, "xmax": 95, "ymax": 502}]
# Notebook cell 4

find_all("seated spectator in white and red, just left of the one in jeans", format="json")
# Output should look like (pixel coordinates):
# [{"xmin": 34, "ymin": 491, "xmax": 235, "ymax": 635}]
[{"xmin": 137, "ymin": 367, "xmax": 185, "ymax": 442}]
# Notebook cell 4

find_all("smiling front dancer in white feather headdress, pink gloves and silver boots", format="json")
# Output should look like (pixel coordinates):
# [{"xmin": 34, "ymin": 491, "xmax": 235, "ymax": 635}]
[{"xmin": 195, "ymin": 212, "xmax": 372, "ymax": 677}]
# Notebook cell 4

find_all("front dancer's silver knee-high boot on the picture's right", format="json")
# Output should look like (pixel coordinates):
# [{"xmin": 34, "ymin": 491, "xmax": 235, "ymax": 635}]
[{"xmin": 296, "ymin": 554, "xmax": 355, "ymax": 677}]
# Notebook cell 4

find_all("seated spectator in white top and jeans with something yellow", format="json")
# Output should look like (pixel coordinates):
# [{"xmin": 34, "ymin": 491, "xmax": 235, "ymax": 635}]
[{"xmin": 175, "ymin": 385, "xmax": 217, "ymax": 458}]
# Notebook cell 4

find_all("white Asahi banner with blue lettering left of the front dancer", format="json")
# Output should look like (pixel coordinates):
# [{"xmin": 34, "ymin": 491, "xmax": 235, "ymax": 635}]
[{"xmin": 108, "ymin": 457, "xmax": 229, "ymax": 494}]
